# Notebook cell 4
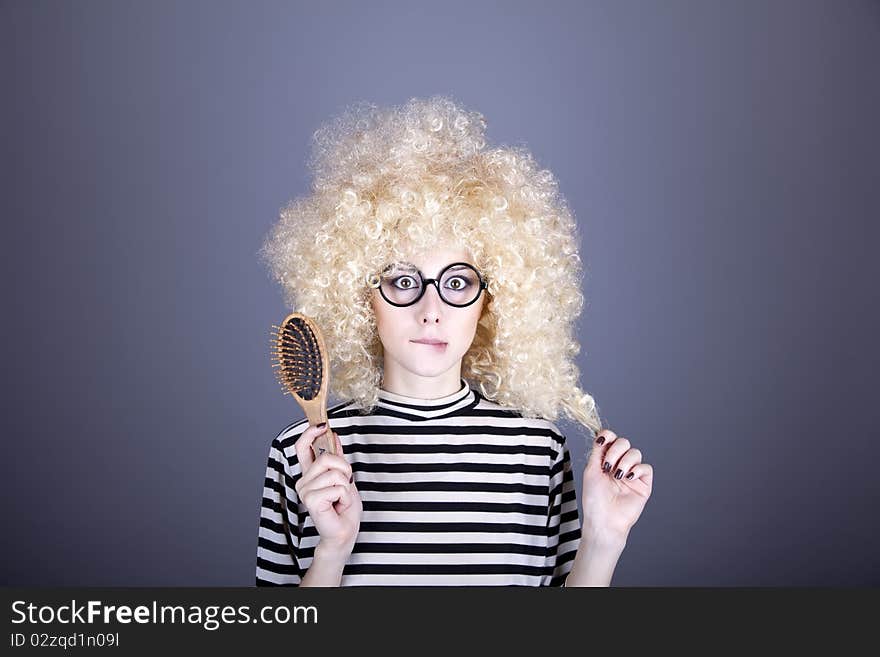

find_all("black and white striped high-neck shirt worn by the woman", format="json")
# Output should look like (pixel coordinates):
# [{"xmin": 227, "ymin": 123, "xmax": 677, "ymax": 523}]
[{"xmin": 256, "ymin": 379, "xmax": 581, "ymax": 586}]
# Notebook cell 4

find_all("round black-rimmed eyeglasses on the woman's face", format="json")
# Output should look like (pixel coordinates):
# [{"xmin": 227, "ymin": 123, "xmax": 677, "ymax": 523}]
[{"xmin": 367, "ymin": 262, "xmax": 487, "ymax": 308}]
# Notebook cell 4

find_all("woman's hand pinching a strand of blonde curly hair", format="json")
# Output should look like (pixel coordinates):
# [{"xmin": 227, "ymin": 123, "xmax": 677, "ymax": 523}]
[{"xmin": 582, "ymin": 429, "xmax": 654, "ymax": 543}]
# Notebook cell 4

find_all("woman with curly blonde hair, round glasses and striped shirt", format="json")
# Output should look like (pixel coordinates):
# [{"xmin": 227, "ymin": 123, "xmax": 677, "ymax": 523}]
[{"xmin": 256, "ymin": 96, "xmax": 653, "ymax": 586}]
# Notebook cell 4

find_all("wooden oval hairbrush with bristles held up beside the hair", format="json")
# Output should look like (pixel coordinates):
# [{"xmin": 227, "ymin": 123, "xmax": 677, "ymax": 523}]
[{"xmin": 272, "ymin": 313, "xmax": 336, "ymax": 458}]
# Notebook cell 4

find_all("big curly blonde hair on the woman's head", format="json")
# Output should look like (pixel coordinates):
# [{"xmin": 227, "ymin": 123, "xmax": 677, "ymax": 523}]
[{"xmin": 258, "ymin": 96, "xmax": 602, "ymax": 433}]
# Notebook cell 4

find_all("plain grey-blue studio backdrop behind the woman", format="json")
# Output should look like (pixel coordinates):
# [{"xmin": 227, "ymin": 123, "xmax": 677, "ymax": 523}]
[{"xmin": 0, "ymin": 0, "xmax": 880, "ymax": 586}]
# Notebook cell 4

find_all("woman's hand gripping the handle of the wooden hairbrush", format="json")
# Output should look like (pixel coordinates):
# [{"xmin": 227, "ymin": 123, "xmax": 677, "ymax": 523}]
[{"xmin": 294, "ymin": 424, "xmax": 363, "ymax": 558}]
